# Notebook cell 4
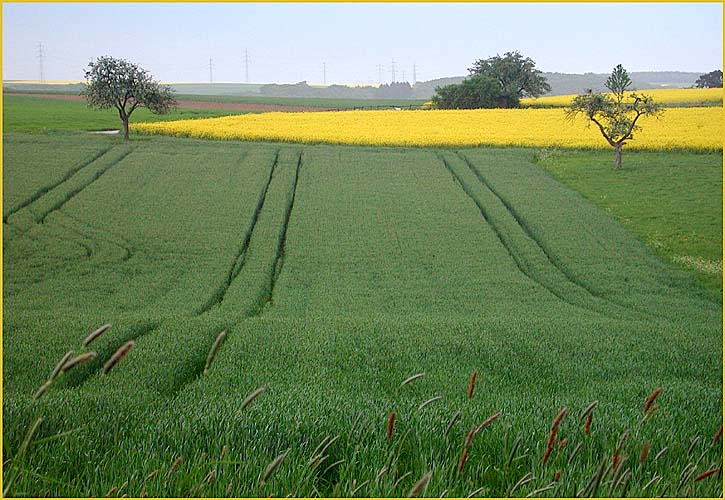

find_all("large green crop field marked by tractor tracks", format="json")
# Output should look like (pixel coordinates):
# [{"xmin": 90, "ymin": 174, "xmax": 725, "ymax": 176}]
[{"xmin": 3, "ymin": 132, "xmax": 723, "ymax": 497}]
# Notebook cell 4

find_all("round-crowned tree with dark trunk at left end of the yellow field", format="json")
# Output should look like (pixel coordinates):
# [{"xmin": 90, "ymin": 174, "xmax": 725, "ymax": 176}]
[{"xmin": 81, "ymin": 56, "xmax": 177, "ymax": 140}]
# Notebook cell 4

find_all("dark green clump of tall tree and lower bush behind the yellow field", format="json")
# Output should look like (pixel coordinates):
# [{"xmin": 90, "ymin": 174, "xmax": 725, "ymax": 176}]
[{"xmin": 433, "ymin": 52, "xmax": 551, "ymax": 109}]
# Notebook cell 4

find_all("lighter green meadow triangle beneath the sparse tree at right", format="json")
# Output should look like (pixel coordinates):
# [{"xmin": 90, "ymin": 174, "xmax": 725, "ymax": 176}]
[{"xmin": 540, "ymin": 150, "xmax": 723, "ymax": 295}]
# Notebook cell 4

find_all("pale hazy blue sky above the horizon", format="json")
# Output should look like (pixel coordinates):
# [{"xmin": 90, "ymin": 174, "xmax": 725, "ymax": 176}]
[{"xmin": 2, "ymin": 3, "xmax": 723, "ymax": 83}]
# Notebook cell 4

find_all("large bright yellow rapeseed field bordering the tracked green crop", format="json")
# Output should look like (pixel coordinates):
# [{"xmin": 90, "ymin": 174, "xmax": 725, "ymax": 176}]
[{"xmin": 133, "ymin": 107, "xmax": 723, "ymax": 150}]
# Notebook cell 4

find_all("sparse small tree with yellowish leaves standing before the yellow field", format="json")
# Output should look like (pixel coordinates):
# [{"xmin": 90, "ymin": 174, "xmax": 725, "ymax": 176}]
[{"xmin": 566, "ymin": 64, "xmax": 663, "ymax": 169}]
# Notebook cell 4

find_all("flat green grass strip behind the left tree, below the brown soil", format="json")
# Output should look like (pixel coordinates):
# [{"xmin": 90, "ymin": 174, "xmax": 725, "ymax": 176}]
[{"xmin": 3, "ymin": 94, "xmax": 255, "ymax": 133}]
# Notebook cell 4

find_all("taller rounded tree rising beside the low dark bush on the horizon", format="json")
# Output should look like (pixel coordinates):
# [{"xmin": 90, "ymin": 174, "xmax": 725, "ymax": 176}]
[{"xmin": 468, "ymin": 51, "xmax": 551, "ymax": 106}]
